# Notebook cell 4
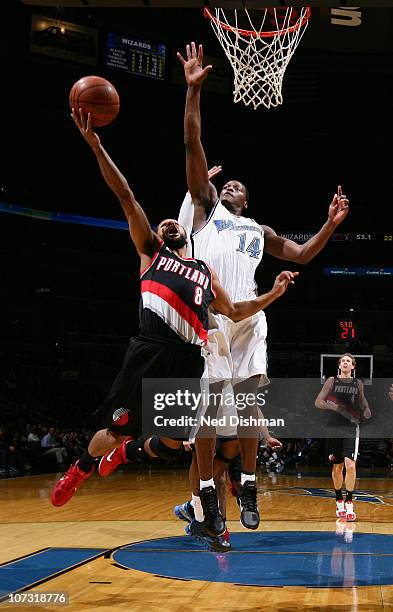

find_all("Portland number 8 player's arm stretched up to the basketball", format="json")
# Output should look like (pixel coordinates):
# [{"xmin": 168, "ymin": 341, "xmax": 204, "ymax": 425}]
[{"xmin": 72, "ymin": 108, "xmax": 160, "ymax": 264}]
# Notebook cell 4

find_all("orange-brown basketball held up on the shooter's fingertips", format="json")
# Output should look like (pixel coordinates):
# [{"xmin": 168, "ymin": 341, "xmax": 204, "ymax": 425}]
[{"xmin": 69, "ymin": 76, "xmax": 120, "ymax": 127}]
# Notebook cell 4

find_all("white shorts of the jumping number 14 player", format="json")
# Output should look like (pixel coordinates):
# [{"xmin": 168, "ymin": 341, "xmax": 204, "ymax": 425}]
[{"xmin": 206, "ymin": 311, "xmax": 267, "ymax": 382}]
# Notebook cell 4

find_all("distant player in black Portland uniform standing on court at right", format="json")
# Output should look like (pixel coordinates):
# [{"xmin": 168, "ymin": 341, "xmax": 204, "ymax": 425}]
[{"xmin": 315, "ymin": 353, "xmax": 371, "ymax": 521}]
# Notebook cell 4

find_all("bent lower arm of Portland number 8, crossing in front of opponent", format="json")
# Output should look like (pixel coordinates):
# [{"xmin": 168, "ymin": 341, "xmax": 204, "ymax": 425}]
[{"xmin": 212, "ymin": 270, "xmax": 299, "ymax": 321}]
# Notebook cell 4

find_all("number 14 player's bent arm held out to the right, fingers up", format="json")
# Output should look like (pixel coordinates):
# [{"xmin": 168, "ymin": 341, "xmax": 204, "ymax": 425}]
[{"xmin": 263, "ymin": 185, "xmax": 349, "ymax": 264}]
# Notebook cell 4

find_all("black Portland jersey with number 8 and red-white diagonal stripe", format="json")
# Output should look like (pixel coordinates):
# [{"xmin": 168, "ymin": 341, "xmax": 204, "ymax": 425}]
[{"xmin": 139, "ymin": 243, "xmax": 216, "ymax": 346}]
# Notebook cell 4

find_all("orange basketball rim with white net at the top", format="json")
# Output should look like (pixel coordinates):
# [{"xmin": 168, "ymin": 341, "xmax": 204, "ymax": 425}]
[{"xmin": 204, "ymin": 7, "xmax": 311, "ymax": 108}]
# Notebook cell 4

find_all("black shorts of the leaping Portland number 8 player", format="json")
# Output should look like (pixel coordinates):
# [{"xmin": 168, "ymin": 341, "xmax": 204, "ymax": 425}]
[{"xmin": 97, "ymin": 337, "xmax": 205, "ymax": 437}]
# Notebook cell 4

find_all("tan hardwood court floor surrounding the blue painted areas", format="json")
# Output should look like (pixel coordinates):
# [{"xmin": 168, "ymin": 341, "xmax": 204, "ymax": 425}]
[{"xmin": 0, "ymin": 470, "xmax": 393, "ymax": 612}]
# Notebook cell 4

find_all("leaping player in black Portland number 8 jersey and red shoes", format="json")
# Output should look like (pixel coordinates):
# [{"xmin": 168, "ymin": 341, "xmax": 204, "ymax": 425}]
[{"xmin": 51, "ymin": 109, "xmax": 297, "ymax": 536}]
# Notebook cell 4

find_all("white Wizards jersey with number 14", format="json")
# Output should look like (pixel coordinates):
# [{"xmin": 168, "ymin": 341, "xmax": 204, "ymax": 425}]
[{"xmin": 179, "ymin": 194, "xmax": 264, "ymax": 302}]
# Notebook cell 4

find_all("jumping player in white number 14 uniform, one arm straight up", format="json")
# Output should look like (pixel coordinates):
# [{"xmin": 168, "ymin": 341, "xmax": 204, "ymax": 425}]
[{"xmin": 177, "ymin": 43, "xmax": 348, "ymax": 529}]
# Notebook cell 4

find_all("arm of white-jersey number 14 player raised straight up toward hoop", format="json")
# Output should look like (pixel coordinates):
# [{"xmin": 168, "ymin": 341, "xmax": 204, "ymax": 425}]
[{"xmin": 177, "ymin": 43, "xmax": 213, "ymax": 228}]
